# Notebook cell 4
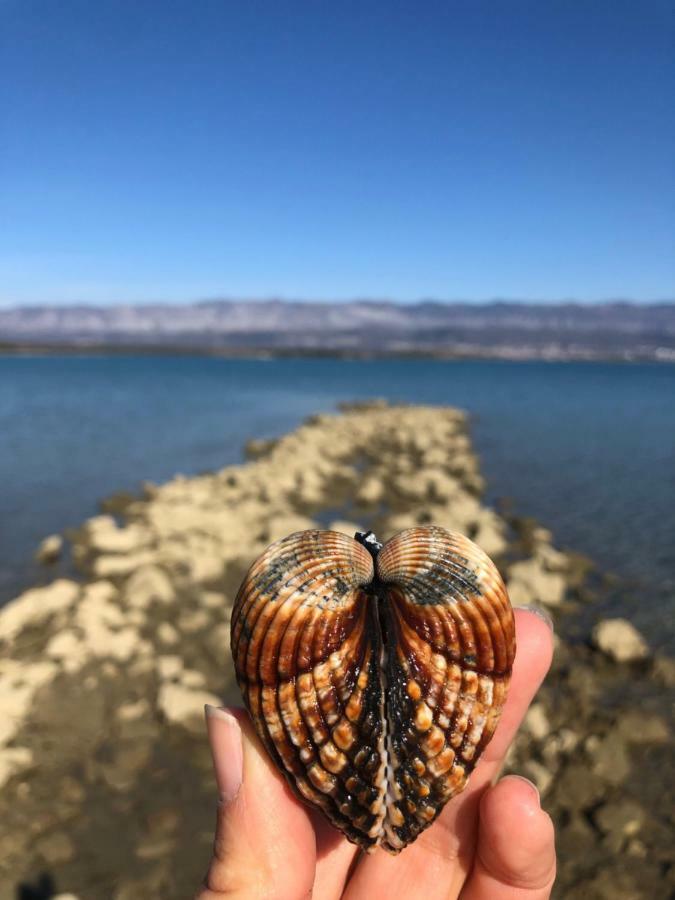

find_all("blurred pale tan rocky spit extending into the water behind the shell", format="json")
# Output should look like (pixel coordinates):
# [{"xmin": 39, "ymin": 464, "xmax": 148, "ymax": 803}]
[{"xmin": 0, "ymin": 403, "xmax": 675, "ymax": 900}]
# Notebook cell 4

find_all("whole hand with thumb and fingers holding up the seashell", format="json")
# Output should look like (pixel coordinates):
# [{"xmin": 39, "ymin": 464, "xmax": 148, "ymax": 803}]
[{"xmin": 197, "ymin": 610, "xmax": 555, "ymax": 900}]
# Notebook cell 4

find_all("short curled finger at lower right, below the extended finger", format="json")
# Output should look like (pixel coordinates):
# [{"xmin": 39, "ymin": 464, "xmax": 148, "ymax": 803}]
[{"xmin": 460, "ymin": 775, "xmax": 555, "ymax": 900}]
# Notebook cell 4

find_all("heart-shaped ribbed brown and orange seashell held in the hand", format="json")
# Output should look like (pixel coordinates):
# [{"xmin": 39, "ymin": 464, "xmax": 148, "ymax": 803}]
[{"xmin": 232, "ymin": 526, "xmax": 515, "ymax": 853}]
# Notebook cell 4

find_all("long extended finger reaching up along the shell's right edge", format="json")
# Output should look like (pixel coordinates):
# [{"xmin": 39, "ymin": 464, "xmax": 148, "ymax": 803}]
[{"xmin": 346, "ymin": 609, "xmax": 553, "ymax": 900}]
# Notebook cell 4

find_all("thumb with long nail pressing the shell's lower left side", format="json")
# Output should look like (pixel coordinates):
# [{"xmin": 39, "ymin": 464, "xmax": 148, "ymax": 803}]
[{"xmin": 197, "ymin": 706, "xmax": 316, "ymax": 900}]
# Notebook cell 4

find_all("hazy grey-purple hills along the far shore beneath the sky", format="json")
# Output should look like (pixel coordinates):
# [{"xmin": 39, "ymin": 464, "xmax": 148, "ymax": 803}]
[{"xmin": 0, "ymin": 300, "xmax": 675, "ymax": 361}]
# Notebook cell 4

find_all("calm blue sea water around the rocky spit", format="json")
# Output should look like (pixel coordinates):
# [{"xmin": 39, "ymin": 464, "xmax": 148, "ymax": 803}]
[{"xmin": 0, "ymin": 356, "xmax": 675, "ymax": 643}]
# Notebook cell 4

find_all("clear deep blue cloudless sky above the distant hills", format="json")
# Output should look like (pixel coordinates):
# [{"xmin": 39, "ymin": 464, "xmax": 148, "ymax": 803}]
[{"xmin": 0, "ymin": 0, "xmax": 675, "ymax": 307}]
